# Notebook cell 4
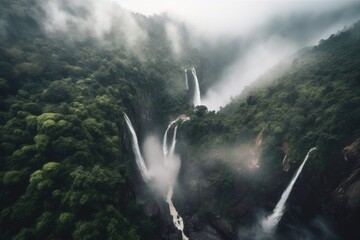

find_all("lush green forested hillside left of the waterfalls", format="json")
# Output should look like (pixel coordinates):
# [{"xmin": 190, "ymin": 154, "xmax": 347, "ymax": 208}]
[{"xmin": 0, "ymin": 1, "xmax": 194, "ymax": 239}]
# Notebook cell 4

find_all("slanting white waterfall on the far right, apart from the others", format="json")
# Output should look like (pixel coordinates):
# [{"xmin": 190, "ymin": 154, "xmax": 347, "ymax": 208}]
[{"xmin": 261, "ymin": 148, "xmax": 316, "ymax": 233}]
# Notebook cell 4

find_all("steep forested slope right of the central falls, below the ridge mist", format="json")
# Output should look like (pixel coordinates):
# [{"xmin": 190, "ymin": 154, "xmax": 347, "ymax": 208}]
[{"xmin": 182, "ymin": 23, "xmax": 360, "ymax": 239}]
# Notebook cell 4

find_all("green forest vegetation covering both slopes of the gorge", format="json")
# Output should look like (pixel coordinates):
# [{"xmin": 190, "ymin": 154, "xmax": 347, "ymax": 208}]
[{"xmin": 0, "ymin": 0, "xmax": 360, "ymax": 240}]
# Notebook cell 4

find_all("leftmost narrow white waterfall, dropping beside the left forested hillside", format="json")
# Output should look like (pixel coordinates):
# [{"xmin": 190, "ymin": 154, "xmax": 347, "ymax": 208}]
[{"xmin": 124, "ymin": 113, "xmax": 150, "ymax": 182}]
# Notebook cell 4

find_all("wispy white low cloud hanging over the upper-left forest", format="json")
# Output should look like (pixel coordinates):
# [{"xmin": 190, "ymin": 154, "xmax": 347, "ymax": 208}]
[{"xmin": 38, "ymin": 0, "xmax": 148, "ymax": 51}]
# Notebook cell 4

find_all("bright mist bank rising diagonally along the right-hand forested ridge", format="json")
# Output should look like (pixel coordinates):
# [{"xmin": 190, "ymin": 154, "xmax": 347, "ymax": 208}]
[{"xmin": 202, "ymin": 1, "xmax": 360, "ymax": 110}]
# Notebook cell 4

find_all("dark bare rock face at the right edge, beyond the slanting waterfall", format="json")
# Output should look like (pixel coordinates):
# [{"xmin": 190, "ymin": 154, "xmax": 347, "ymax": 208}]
[{"xmin": 332, "ymin": 139, "xmax": 360, "ymax": 239}]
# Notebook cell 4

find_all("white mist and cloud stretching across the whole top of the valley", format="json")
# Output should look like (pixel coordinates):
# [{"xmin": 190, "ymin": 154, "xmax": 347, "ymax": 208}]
[{"xmin": 25, "ymin": 0, "xmax": 360, "ymax": 110}]
